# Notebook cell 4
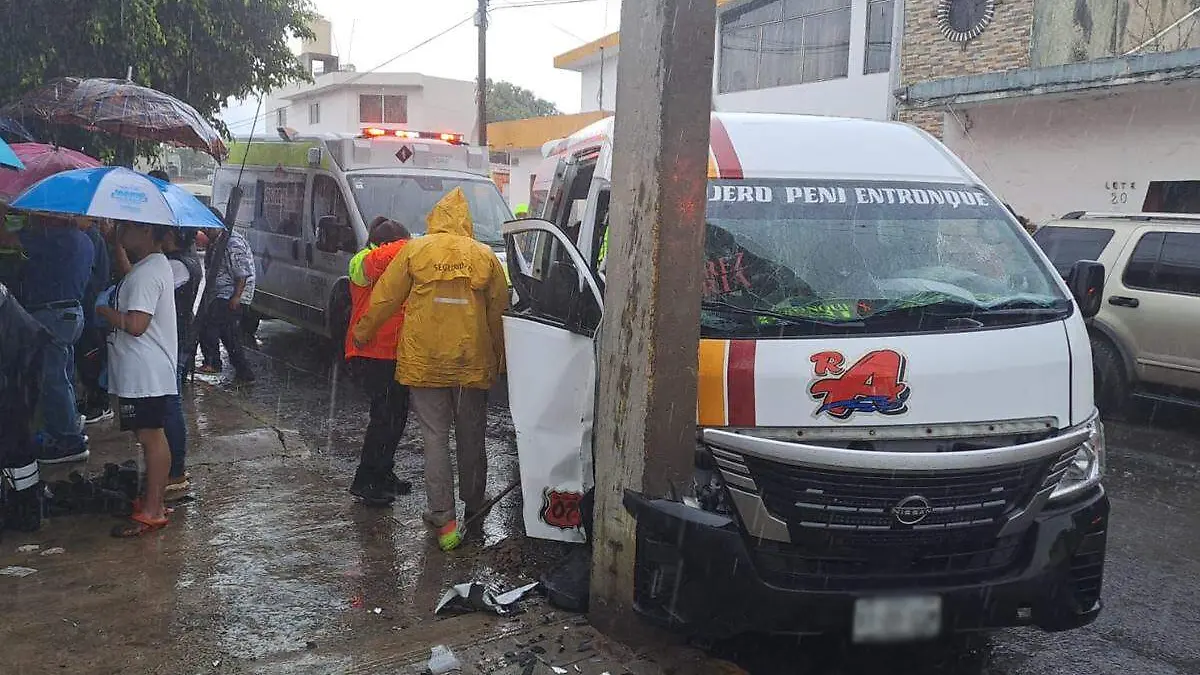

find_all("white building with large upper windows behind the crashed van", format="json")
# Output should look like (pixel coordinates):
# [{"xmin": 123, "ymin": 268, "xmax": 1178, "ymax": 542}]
[{"xmin": 554, "ymin": 0, "xmax": 902, "ymax": 119}]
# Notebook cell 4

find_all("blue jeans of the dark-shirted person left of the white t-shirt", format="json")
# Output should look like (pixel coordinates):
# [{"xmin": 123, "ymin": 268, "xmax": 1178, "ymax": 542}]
[{"xmin": 30, "ymin": 303, "xmax": 84, "ymax": 448}]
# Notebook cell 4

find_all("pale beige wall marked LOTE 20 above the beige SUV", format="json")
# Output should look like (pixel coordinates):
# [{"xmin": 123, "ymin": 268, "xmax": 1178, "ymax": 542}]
[{"xmin": 944, "ymin": 84, "xmax": 1200, "ymax": 222}]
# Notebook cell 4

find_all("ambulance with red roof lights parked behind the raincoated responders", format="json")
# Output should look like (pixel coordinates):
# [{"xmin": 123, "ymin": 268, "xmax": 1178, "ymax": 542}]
[{"xmin": 212, "ymin": 127, "xmax": 512, "ymax": 344}]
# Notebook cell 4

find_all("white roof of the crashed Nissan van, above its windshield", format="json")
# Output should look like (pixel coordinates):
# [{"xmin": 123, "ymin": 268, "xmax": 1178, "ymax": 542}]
[{"xmin": 542, "ymin": 113, "xmax": 979, "ymax": 184}]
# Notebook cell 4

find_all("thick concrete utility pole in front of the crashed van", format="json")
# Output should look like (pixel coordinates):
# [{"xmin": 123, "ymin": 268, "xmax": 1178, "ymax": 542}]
[{"xmin": 590, "ymin": 0, "xmax": 716, "ymax": 633}]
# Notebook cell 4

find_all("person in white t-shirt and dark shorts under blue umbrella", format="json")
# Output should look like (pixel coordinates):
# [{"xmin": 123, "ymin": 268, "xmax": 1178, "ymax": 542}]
[{"xmin": 96, "ymin": 222, "xmax": 179, "ymax": 537}]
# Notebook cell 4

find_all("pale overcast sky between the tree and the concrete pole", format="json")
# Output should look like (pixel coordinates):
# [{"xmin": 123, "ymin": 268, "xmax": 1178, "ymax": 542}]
[{"xmin": 222, "ymin": 0, "xmax": 620, "ymax": 135}]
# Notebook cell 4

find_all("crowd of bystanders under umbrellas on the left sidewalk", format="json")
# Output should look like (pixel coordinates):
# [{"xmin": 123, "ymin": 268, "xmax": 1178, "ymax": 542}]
[{"xmin": 0, "ymin": 172, "xmax": 254, "ymax": 536}]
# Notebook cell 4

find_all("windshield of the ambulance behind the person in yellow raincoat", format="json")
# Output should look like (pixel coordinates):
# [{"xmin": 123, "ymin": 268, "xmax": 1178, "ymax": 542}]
[{"xmin": 348, "ymin": 173, "xmax": 512, "ymax": 246}]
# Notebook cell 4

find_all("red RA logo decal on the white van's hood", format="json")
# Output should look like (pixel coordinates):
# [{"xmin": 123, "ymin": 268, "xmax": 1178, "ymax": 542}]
[{"xmin": 809, "ymin": 350, "xmax": 911, "ymax": 419}]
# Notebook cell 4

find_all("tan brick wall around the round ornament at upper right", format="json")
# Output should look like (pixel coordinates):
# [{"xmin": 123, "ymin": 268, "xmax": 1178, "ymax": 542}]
[{"xmin": 898, "ymin": 0, "xmax": 1034, "ymax": 138}]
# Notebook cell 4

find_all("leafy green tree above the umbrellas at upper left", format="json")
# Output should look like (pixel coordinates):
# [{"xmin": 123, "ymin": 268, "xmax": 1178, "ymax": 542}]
[{"xmin": 0, "ymin": 0, "xmax": 314, "ymax": 156}]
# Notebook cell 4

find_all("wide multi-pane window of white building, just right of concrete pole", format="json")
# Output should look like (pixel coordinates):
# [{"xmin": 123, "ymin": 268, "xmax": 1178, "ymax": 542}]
[{"xmin": 719, "ymin": 0, "xmax": 854, "ymax": 92}]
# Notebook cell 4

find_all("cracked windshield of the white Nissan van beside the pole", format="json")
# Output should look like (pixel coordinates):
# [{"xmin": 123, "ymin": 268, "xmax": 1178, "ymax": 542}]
[{"xmin": 702, "ymin": 179, "xmax": 1072, "ymax": 338}]
